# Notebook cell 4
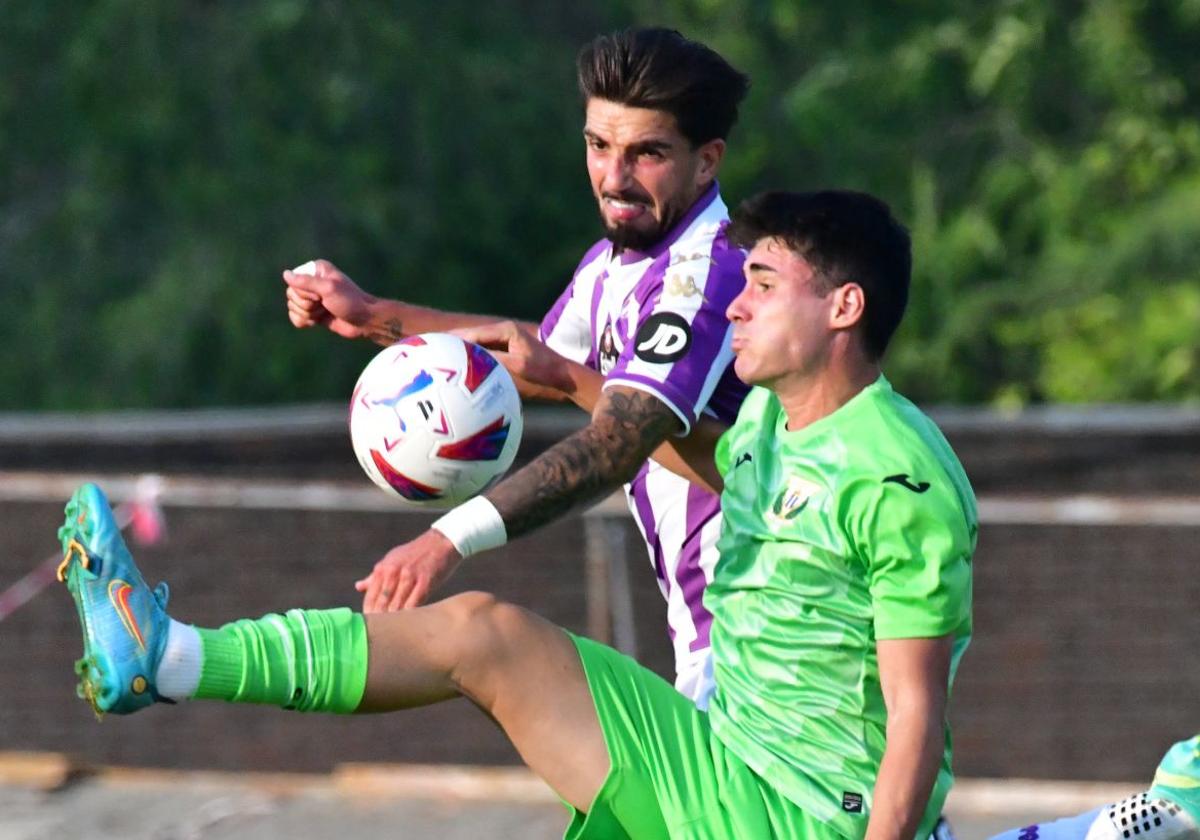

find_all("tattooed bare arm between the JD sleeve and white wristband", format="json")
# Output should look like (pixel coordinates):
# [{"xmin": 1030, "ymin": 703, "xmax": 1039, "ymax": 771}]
[{"xmin": 487, "ymin": 388, "xmax": 679, "ymax": 539}]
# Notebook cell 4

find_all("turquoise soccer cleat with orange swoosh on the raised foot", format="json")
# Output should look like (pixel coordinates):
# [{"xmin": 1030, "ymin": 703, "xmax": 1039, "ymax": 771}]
[{"xmin": 58, "ymin": 484, "xmax": 169, "ymax": 716}]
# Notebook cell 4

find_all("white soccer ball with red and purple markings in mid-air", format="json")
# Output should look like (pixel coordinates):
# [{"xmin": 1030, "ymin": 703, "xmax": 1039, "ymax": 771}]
[{"xmin": 350, "ymin": 332, "xmax": 522, "ymax": 508}]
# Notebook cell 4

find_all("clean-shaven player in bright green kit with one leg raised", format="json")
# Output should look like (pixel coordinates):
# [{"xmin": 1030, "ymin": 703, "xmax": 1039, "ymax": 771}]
[{"xmin": 60, "ymin": 192, "xmax": 977, "ymax": 840}]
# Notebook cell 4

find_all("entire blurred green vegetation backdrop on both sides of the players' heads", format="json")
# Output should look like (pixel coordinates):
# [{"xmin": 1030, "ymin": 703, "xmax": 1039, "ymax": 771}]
[{"xmin": 0, "ymin": 0, "xmax": 1200, "ymax": 409}]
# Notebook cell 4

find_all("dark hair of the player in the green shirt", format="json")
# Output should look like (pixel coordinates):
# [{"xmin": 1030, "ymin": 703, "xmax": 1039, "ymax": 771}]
[{"xmin": 728, "ymin": 190, "xmax": 912, "ymax": 359}]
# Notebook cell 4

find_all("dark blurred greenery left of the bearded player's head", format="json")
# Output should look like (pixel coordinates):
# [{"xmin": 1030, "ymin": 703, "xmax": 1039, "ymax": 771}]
[{"xmin": 0, "ymin": 0, "xmax": 613, "ymax": 408}]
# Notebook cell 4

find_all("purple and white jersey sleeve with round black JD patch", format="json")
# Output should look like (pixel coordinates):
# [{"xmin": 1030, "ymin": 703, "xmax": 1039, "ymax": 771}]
[{"xmin": 604, "ymin": 234, "xmax": 744, "ymax": 434}]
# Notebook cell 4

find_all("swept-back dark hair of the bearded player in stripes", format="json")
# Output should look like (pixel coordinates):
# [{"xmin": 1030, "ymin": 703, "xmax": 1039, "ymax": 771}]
[{"xmin": 576, "ymin": 29, "xmax": 750, "ymax": 148}]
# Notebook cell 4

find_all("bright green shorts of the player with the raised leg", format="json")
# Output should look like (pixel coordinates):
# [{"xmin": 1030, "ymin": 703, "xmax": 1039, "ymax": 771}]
[{"xmin": 564, "ymin": 635, "xmax": 845, "ymax": 840}]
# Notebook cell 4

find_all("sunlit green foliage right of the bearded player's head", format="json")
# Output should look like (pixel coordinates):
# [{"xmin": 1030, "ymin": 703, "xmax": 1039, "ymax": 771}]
[{"xmin": 646, "ymin": 0, "xmax": 1200, "ymax": 404}]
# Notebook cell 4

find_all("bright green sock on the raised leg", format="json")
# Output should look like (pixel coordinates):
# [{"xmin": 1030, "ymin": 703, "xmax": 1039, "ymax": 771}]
[{"xmin": 194, "ymin": 607, "xmax": 367, "ymax": 714}]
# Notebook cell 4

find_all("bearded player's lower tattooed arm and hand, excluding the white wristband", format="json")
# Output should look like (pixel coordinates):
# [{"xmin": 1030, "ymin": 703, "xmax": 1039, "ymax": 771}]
[{"xmin": 355, "ymin": 386, "xmax": 680, "ymax": 612}]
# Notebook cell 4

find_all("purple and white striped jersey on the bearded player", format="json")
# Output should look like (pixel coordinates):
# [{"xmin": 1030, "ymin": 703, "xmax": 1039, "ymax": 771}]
[{"xmin": 539, "ymin": 184, "xmax": 746, "ymax": 708}]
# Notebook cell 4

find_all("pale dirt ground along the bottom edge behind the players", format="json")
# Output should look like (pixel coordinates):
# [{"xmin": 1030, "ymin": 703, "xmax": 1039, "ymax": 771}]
[{"xmin": 0, "ymin": 762, "xmax": 1138, "ymax": 840}]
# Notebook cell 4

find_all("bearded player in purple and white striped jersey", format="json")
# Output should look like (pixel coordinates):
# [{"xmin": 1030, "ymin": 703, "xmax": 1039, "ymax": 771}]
[{"xmin": 283, "ymin": 29, "xmax": 748, "ymax": 706}]
